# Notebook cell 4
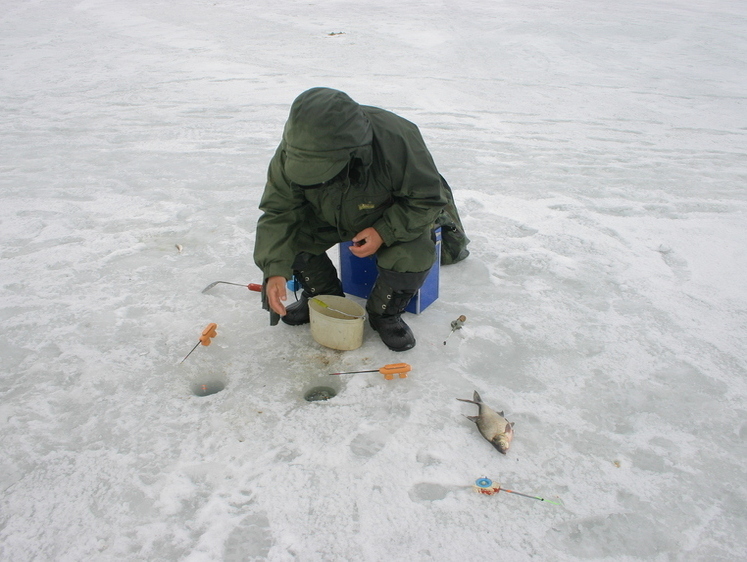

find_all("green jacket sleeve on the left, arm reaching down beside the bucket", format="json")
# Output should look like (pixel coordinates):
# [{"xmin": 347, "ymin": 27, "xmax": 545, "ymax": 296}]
[{"xmin": 254, "ymin": 144, "xmax": 307, "ymax": 279}]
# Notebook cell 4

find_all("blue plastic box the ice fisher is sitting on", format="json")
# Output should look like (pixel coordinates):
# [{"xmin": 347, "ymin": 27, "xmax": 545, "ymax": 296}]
[{"xmin": 340, "ymin": 227, "xmax": 441, "ymax": 314}]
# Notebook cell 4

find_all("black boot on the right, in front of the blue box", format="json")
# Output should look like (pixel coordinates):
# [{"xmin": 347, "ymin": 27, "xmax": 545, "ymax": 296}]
[{"xmin": 366, "ymin": 268, "xmax": 430, "ymax": 351}]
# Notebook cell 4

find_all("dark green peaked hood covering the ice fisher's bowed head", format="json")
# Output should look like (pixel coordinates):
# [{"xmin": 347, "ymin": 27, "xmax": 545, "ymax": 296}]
[{"xmin": 283, "ymin": 88, "xmax": 373, "ymax": 185}]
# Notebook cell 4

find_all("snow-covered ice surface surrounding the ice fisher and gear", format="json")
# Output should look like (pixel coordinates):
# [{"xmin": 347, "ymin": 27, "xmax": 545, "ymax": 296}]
[{"xmin": 0, "ymin": 0, "xmax": 747, "ymax": 562}]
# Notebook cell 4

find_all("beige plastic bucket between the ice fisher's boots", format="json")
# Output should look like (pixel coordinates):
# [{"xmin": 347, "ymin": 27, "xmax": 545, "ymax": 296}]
[{"xmin": 309, "ymin": 295, "xmax": 366, "ymax": 351}]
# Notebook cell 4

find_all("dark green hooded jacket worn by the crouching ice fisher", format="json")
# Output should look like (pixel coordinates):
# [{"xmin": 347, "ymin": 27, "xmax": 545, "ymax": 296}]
[{"xmin": 254, "ymin": 88, "xmax": 453, "ymax": 279}]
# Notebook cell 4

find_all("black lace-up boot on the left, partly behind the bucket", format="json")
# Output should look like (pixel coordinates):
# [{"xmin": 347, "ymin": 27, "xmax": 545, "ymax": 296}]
[{"xmin": 282, "ymin": 252, "xmax": 345, "ymax": 326}]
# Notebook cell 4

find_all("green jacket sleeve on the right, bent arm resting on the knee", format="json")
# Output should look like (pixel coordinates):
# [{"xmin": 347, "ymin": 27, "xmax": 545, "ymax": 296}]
[{"xmin": 373, "ymin": 117, "xmax": 448, "ymax": 246}]
